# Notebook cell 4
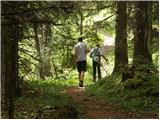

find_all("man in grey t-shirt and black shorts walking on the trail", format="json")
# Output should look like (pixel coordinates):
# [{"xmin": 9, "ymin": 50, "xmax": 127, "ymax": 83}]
[{"xmin": 74, "ymin": 37, "xmax": 89, "ymax": 87}]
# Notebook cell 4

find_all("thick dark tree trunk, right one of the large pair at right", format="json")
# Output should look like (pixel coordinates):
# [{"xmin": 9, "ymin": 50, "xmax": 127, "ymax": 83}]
[{"xmin": 133, "ymin": 1, "xmax": 152, "ymax": 67}]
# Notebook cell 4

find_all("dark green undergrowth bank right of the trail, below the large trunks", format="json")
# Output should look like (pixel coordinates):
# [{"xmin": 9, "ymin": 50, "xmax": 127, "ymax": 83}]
[{"xmin": 86, "ymin": 72, "xmax": 159, "ymax": 114}]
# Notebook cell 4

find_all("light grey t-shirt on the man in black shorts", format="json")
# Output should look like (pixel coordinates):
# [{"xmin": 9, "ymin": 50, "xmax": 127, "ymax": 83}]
[{"xmin": 74, "ymin": 42, "xmax": 87, "ymax": 62}]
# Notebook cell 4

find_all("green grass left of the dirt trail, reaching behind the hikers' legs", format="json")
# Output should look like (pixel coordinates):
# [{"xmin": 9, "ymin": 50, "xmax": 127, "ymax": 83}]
[{"xmin": 14, "ymin": 70, "xmax": 92, "ymax": 119}]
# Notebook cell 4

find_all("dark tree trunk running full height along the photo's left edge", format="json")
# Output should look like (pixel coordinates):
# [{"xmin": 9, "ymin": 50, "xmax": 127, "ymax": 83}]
[{"xmin": 1, "ymin": 1, "xmax": 20, "ymax": 119}]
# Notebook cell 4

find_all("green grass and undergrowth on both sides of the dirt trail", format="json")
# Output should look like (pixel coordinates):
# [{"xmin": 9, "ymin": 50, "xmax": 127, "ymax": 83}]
[{"xmin": 15, "ymin": 62, "xmax": 159, "ymax": 119}]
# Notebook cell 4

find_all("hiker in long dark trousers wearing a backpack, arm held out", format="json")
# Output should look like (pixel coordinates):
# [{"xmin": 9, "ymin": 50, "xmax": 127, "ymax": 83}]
[{"xmin": 90, "ymin": 44, "xmax": 108, "ymax": 82}]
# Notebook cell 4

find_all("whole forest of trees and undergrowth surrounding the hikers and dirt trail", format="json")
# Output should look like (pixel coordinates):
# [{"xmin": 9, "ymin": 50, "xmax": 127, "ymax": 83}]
[{"xmin": 1, "ymin": 1, "xmax": 159, "ymax": 118}]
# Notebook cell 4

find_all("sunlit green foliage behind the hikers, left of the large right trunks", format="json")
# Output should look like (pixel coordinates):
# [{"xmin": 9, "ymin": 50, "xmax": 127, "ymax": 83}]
[{"xmin": 19, "ymin": 1, "xmax": 115, "ymax": 78}]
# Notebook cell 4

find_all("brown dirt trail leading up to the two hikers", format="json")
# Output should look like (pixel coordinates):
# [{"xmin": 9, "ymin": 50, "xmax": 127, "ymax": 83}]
[{"xmin": 65, "ymin": 87, "xmax": 141, "ymax": 119}]
